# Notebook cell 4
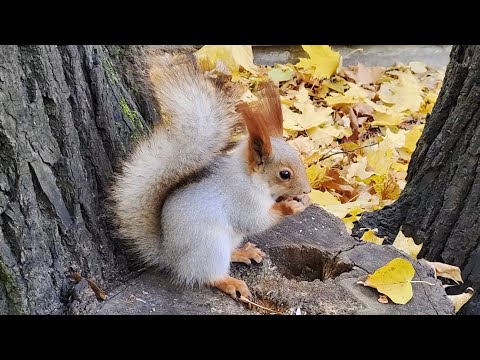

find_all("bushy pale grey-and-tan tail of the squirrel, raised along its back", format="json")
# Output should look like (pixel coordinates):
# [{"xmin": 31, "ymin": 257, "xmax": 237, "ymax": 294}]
[{"xmin": 111, "ymin": 54, "xmax": 240, "ymax": 265}]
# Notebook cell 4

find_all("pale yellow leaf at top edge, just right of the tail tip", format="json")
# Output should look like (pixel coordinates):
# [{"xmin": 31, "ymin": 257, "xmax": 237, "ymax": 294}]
[{"xmin": 196, "ymin": 45, "xmax": 258, "ymax": 81}]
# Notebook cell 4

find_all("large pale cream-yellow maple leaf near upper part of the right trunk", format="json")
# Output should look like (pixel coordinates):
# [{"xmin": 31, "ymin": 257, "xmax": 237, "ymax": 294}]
[{"xmin": 378, "ymin": 72, "xmax": 423, "ymax": 113}]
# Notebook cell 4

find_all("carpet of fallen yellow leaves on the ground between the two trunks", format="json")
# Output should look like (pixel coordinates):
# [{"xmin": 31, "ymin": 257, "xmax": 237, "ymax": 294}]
[{"xmin": 197, "ymin": 45, "xmax": 444, "ymax": 231}]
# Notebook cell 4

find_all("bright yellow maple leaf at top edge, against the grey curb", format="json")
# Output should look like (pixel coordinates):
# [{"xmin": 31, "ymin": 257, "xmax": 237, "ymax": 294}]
[{"xmin": 295, "ymin": 45, "xmax": 340, "ymax": 78}]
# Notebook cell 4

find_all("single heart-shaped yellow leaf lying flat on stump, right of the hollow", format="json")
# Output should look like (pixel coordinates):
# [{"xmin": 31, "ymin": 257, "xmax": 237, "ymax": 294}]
[{"xmin": 364, "ymin": 258, "xmax": 415, "ymax": 305}]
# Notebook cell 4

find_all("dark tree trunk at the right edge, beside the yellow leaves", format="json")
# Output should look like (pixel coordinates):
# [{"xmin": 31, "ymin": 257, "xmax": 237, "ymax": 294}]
[{"xmin": 356, "ymin": 45, "xmax": 480, "ymax": 314}]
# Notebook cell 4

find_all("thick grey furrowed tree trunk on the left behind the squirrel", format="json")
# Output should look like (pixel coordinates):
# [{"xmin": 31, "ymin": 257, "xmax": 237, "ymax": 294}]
[{"xmin": 0, "ymin": 46, "xmax": 150, "ymax": 314}]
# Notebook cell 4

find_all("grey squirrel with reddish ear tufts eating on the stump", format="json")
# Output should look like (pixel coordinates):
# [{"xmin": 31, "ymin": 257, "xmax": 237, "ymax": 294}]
[{"xmin": 111, "ymin": 54, "xmax": 311, "ymax": 299}]
